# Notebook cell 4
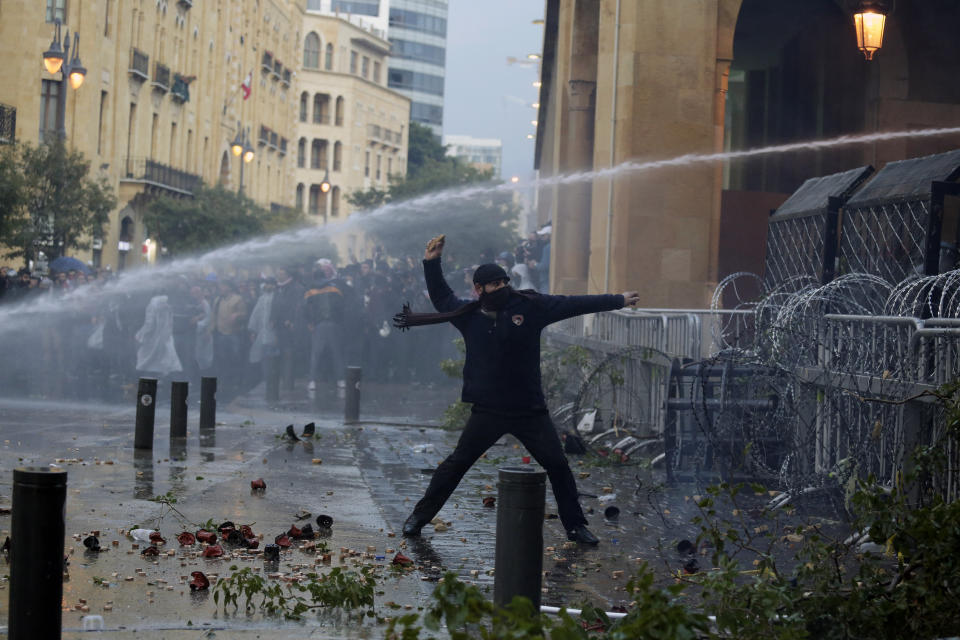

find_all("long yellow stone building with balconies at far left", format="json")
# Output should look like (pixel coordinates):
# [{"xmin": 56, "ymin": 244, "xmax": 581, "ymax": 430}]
[{"xmin": 0, "ymin": 0, "xmax": 302, "ymax": 269}]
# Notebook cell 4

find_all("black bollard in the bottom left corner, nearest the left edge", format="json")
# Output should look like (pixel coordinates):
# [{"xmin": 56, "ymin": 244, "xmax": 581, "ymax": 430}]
[{"xmin": 8, "ymin": 467, "xmax": 67, "ymax": 640}]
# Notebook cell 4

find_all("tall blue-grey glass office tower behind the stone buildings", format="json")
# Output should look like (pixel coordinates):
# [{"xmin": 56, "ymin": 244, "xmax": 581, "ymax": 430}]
[{"xmin": 387, "ymin": 0, "xmax": 449, "ymax": 136}]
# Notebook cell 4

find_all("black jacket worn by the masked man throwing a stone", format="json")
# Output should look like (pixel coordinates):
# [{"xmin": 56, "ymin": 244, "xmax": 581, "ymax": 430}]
[{"xmin": 423, "ymin": 258, "xmax": 623, "ymax": 410}]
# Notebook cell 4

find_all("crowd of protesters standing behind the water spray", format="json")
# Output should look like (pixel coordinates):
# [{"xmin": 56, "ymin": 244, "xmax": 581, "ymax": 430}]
[{"xmin": 0, "ymin": 228, "xmax": 549, "ymax": 404}]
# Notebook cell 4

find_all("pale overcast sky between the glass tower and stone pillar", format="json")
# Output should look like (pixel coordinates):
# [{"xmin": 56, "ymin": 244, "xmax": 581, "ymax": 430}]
[{"xmin": 443, "ymin": 0, "xmax": 544, "ymax": 179}]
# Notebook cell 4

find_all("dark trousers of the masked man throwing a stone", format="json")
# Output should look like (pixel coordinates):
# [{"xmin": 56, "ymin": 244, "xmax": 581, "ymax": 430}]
[{"xmin": 413, "ymin": 408, "xmax": 587, "ymax": 530}]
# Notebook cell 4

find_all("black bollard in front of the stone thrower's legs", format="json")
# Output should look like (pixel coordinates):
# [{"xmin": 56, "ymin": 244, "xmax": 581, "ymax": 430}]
[{"xmin": 493, "ymin": 467, "xmax": 547, "ymax": 611}]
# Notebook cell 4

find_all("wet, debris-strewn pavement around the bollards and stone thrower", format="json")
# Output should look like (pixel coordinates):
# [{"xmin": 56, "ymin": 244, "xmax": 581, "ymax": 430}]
[{"xmin": 0, "ymin": 383, "xmax": 824, "ymax": 638}]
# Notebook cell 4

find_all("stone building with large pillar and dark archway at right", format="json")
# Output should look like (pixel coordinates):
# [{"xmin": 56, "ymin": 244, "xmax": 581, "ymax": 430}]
[{"xmin": 536, "ymin": 0, "xmax": 960, "ymax": 308}]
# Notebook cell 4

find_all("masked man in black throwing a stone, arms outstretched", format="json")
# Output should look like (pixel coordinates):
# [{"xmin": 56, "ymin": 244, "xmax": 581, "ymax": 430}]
[{"xmin": 394, "ymin": 236, "xmax": 639, "ymax": 544}]
